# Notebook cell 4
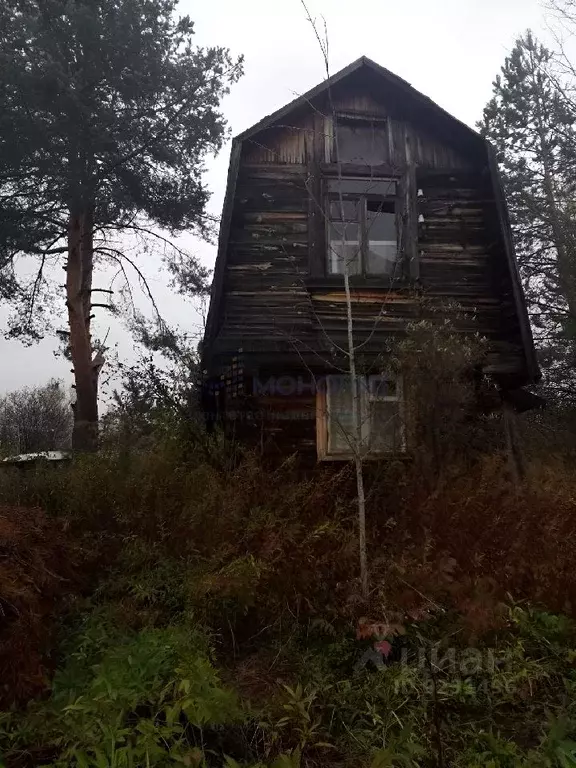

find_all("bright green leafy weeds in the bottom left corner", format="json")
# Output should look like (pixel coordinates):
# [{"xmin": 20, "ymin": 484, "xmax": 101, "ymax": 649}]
[{"xmin": 4, "ymin": 612, "xmax": 241, "ymax": 768}]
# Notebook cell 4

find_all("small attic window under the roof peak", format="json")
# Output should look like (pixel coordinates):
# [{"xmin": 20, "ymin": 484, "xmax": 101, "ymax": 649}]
[{"xmin": 326, "ymin": 114, "xmax": 387, "ymax": 167}]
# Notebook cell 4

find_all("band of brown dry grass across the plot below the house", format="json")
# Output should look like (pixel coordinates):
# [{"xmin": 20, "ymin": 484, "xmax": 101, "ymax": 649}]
[{"xmin": 0, "ymin": 446, "xmax": 576, "ymax": 695}]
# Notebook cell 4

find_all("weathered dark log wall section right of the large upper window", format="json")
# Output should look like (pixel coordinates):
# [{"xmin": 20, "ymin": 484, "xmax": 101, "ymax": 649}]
[{"xmin": 417, "ymin": 169, "xmax": 525, "ymax": 375}]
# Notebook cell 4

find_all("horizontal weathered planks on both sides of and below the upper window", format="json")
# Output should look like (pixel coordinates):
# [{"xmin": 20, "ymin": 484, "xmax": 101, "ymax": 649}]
[{"xmin": 214, "ymin": 129, "xmax": 521, "ymax": 378}]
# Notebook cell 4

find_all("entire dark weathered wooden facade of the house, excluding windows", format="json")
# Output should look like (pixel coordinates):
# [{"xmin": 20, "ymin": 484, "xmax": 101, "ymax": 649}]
[{"xmin": 204, "ymin": 60, "xmax": 531, "ymax": 460}]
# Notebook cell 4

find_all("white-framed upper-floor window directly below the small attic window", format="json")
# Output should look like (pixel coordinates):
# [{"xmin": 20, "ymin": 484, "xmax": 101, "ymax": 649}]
[{"xmin": 326, "ymin": 178, "xmax": 398, "ymax": 276}]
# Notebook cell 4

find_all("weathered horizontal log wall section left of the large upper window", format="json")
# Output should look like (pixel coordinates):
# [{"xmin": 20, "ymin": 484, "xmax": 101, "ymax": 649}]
[{"xmin": 213, "ymin": 165, "xmax": 314, "ymax": 372}]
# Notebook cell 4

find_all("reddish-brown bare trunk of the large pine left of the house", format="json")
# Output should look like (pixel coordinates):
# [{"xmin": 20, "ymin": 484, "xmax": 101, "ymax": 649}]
[{"xmin": 66, "ymin": 211, "xmax": 100, "ymax": 451}]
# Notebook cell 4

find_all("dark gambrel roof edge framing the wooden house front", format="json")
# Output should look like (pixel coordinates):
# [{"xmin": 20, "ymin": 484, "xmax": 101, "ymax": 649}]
[{"xmin": 202, "ymin": 56, "xmax": 540, "ymax": 382}]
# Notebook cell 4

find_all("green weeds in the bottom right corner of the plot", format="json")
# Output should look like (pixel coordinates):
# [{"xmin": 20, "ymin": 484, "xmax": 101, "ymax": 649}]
[{"xmin": 280, "ymin": 605, "xmax": 576, "ymax": 768}]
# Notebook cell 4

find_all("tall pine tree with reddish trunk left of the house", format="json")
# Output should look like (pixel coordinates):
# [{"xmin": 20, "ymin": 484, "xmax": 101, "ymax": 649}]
[{"xmin": 0, "ymin": 0, "xmax": 241, "ymax": 450}]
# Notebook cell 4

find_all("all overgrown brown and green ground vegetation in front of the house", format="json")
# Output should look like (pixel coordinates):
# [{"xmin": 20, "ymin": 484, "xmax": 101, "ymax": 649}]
[{"xmin": 0, "ymin": 419, "xmax": 576, "ymax": 768}]
